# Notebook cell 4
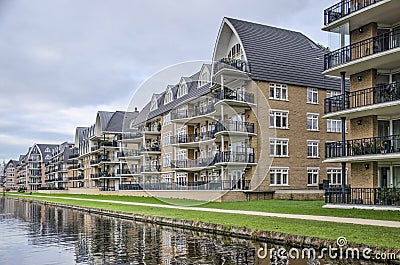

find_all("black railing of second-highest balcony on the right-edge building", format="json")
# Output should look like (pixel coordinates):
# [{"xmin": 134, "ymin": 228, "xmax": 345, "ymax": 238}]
[{"xmin": 324, "ymin": 31, "xmax": 400, "ymax": 70}]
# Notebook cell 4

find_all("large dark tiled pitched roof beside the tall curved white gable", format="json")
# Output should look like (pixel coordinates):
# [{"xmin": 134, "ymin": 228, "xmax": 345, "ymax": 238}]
[{"xmin": 225, "ymin": 18, "xmax": 340, "ymax": 90}]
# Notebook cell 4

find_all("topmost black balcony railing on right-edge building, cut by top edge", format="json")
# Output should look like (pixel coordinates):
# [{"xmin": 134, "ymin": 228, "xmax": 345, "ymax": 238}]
[{"xmin": 324, "ymin": 0, "xmax": 382, "ymax": 26}]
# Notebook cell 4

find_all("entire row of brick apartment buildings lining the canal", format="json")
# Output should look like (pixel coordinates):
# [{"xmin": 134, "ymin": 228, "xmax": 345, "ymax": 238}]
[{"xmin": 5, "ymin": 0, "xmax": 400, "ymax": 201}]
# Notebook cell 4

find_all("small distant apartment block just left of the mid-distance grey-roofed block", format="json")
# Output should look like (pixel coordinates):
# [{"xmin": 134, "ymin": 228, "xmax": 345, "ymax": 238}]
[{"xmin": 43, "ymin": 142, "xmax": 74, "ymax": 190}]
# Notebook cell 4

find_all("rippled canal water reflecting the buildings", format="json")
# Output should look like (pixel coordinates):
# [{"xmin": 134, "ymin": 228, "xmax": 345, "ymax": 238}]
[{"xmin": 0, "ymin": 197, "xmax": 390, "ymax": 265}]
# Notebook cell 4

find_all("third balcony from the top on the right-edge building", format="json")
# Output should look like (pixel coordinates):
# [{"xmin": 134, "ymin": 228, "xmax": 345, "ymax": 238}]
[{"xmin": 324, "ymin": 82, "xmax": 400, "ymax": 118}]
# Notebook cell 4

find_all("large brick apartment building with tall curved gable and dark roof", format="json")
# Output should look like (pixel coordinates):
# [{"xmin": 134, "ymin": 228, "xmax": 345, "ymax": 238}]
[{"xmin": 115, "ymin": 18, "xmax": 341, "ymax": 197}]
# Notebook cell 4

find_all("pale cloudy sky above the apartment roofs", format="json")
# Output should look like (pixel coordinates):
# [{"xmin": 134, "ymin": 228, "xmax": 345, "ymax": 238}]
[{"xmin": 0, "ymin": 0, "xmax": 338, "ymax": 160}]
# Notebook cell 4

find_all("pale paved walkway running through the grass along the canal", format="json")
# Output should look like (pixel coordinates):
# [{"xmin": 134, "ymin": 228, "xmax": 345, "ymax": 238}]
[{"xmin": 8, "ymin": 194, "xmax": 400, "ymax": 228}]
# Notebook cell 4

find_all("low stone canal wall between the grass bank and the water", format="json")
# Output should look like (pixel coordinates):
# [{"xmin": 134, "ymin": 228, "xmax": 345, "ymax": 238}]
[{"xmin": 15, "ymin": 198, "xmax": 400, "ymax": 264}]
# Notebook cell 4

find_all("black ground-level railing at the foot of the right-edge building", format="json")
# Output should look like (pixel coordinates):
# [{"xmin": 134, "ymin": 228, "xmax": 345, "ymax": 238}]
[{"xmin": 324, "ymin": 188, "xmax": 400, "ymax": 206}]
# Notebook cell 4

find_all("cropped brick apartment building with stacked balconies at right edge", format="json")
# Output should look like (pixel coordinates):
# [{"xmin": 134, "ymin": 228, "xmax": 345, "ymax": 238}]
[{"xmin": 323, "ymin": 0, "xmax": 400, "ymax": 205}]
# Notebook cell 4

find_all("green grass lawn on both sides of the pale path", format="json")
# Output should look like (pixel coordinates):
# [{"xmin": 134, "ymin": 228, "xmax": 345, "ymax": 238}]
[{"xmin": 6, "ymin": 194, "xmax": 400, "ymax": 249}]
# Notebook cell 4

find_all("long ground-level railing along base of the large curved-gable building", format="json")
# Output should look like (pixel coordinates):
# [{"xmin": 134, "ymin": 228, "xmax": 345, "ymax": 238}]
[{"xmin": 119, "ymin": 180, "xmax": 250, "ymax": 190}]
